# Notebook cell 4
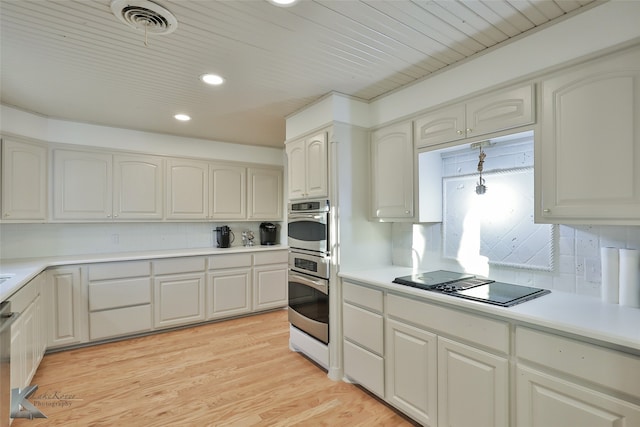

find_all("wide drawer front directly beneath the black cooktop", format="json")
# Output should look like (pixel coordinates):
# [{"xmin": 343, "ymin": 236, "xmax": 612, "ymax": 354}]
[{"xmin": 386, "ymin": 294, "xmax": 509, "ymax": 353}]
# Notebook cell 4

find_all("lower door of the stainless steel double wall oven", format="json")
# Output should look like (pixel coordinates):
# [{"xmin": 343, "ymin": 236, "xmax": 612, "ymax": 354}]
[{"xmin": 289, "ymin": 271, "xmax": 329, "ymax": 344}]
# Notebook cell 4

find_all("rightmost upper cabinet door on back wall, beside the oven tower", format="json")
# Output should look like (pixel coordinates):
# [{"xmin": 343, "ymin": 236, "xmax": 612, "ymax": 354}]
[{"xmin": 247, "ymin": 168, "xmax": 283, "ymax": 221}]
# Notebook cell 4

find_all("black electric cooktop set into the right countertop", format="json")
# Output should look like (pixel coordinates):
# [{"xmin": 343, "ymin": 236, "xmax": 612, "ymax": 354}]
[{"xmin": 393, "ymin": 270, "xmax": 551, "ymax": 307}]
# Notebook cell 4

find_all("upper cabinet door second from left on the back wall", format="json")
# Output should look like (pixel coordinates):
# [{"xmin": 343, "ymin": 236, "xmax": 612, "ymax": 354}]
[{"xmin": 53, "ymin": 150, "xmax": 113, "ymax": 220}]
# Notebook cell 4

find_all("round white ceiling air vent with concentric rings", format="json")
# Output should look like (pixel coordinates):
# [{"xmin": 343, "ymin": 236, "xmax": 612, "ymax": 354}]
[{"xmin": 111, "ymin": 0, "xmax": 178, "ymax": 35}]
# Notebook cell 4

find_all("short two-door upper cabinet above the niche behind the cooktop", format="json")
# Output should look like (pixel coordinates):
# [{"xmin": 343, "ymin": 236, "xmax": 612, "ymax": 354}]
[{"xmin": 415, "ymin": 84, "xmax": 535, "ymax": 148}]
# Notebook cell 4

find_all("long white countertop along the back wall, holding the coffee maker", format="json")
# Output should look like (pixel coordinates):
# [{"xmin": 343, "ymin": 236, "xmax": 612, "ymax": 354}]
[{"xmin": 0, "ymin": 245, "xmax": 289, "ymax": 302}]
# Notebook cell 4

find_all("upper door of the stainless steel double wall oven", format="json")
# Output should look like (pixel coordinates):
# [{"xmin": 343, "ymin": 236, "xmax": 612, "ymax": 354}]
[{"xmin": 287, "ymin": 212, "xmax": 329, "ymax": 253}]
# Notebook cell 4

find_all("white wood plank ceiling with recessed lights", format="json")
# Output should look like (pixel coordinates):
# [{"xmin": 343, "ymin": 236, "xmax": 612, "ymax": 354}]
[{"xmin": 0, "ymin": 0, "xmax": 599, "ymax": 147}]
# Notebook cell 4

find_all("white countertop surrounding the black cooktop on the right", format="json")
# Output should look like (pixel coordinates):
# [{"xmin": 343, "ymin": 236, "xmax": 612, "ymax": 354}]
[{"xmin": 339, "ymin": 266, "xmax": 640, "ymax": 351}]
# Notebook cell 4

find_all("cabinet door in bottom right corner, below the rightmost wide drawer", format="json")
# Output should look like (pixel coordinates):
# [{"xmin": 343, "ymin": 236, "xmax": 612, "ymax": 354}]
[{"xmin": 516, "ymin": 366, "xmax": 640, "ymax": 427}]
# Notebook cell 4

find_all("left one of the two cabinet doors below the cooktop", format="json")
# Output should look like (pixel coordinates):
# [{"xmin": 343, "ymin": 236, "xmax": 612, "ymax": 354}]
[{"xmin": 385, "ymin": 319, "xmax": 438, "ymax": 426}]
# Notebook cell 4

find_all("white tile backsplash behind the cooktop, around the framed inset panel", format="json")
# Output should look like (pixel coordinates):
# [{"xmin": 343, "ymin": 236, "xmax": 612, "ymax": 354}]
[{"xmin": 392, "ymin": 223, "xmax": 640, "ymax": 297}]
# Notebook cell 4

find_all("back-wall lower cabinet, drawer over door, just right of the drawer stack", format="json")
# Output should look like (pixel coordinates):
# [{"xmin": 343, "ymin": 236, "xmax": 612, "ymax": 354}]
[{"xmin": 153, "ymin": 257, "xmax": 205, "ymax": 328}]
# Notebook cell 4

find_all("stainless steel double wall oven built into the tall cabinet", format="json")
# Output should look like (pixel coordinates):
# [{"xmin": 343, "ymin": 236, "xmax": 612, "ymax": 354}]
[{"xmin": 287, "ymin": 199, "xmax": 331, "ymax": 344}]
